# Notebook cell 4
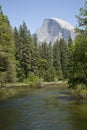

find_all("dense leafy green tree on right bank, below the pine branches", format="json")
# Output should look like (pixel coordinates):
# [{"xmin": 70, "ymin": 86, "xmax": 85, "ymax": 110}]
[{"xmin": 68, "ymin": 36, "xmax": 87, "ymax": 87}]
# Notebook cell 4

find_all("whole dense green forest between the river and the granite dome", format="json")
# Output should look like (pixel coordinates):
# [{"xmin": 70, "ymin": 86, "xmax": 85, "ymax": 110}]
[{"xmin": 0, "ymin": 1, "xmax": 87, "ymax": 88}]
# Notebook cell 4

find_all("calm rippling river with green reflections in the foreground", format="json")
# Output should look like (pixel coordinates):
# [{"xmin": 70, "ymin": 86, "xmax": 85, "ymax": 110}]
[{"xmin": 0, "ymin": 88, "xmax": 87, "ymax": 130}]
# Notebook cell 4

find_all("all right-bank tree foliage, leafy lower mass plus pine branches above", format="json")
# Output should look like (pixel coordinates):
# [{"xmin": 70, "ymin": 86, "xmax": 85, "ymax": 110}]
[{"xmin": 68, "ymin": 2, "xmax": 87, "ymax": 87}]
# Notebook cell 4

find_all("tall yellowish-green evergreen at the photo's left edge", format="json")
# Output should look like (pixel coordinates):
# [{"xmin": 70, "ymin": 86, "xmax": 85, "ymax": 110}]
[{"xmin": 0, "ymin": 7, "xmax": 16, "ymax": 85}]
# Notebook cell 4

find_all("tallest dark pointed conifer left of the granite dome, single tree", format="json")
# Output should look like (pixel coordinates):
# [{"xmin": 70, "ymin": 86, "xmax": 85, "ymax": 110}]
[{"xmin": 19, "ymin": 22, "xmax": 32, "ymax": 78}]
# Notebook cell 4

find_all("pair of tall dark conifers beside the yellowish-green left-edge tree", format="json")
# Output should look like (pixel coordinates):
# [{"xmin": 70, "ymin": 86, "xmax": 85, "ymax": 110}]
[{"xmin": 14, "ymin": 22, "xmax": 33, "ymax": 81}]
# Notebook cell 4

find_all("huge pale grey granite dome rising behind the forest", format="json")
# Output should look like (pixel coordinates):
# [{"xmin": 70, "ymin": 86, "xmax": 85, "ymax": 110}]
[{"xmin": 36, "ymin": 18, "xmax": 75, "ymax": 43}]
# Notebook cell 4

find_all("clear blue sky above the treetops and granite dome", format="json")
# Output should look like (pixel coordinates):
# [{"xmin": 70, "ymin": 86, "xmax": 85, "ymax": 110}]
[{"xmin": 0, "ymin": 0, "xmax": 85, "ymax": 33}]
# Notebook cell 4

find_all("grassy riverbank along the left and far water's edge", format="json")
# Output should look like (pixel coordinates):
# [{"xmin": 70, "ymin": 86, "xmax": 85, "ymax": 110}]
[{"xmin": 0, "ymin": 81, "xmax": 68, "ymax": 100}]
